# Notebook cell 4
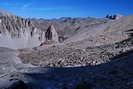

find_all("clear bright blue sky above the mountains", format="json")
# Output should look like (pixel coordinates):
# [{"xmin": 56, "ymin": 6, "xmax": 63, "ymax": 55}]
[{"xmin": 0, "ymin": 0, "xmax": 133, "ymax": 18}]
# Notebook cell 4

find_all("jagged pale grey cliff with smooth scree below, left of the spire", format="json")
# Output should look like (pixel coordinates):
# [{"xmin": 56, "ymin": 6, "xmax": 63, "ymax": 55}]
[{"xmin": 0, "ymin": 16, "xmax": 45, "ymax": 49}]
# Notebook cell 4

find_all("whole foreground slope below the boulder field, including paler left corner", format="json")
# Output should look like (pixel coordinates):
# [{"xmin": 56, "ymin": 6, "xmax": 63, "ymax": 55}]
[{"xmin": 0, "ymin": 48, "xmax": 133, "ymax": 89}]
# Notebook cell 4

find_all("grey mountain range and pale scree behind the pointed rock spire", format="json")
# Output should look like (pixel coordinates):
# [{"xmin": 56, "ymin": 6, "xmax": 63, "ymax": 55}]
[{"xmin": 0, "ymin": 11, "xmax": 107, "ymax": 48}]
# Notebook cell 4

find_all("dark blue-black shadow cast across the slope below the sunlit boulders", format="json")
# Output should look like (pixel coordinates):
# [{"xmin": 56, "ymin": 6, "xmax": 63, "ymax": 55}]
[{"xmin": 25, "ymin": 50, "xmax": 133, "ymax": 89}]
